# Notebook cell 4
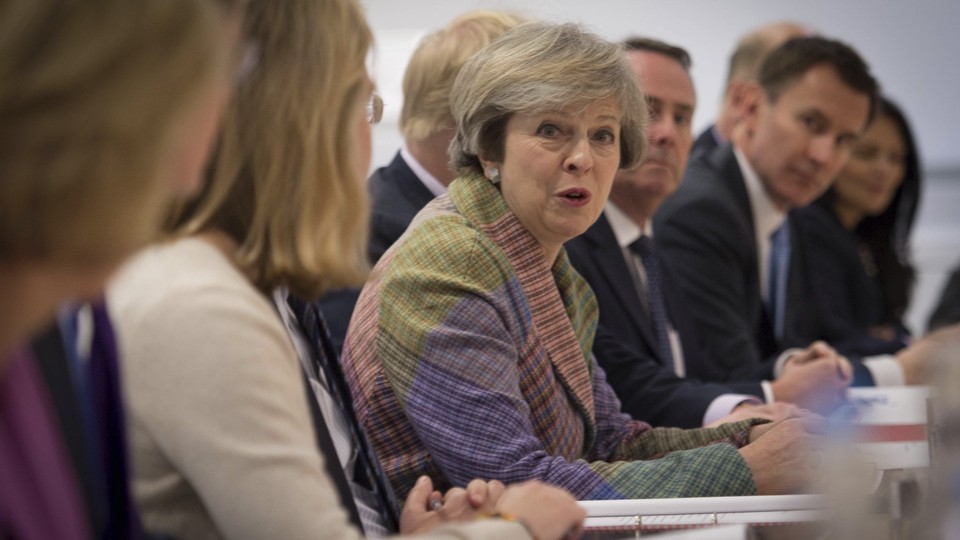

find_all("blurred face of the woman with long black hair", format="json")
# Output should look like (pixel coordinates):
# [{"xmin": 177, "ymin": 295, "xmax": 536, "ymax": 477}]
[{"xmin": 833, "ymin": 116, "xmax": 907, "ymax": 221}]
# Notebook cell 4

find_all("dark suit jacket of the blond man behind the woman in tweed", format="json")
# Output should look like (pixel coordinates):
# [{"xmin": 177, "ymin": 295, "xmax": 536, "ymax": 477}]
[{"xmin": 318, "ymin": 152, "xmax": 433, "ymax": 354}]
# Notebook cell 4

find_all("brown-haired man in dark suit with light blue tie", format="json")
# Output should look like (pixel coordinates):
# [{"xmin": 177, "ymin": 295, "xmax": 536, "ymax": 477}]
[{"xmin": 654, "ymin": 37, "xmax": 913, "ymax": 384}]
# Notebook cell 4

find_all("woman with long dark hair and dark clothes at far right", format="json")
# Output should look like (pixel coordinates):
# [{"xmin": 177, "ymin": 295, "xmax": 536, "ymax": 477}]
[{"xmin": 796, "ymin": 98, "xmax": 922, "ymax": 356}]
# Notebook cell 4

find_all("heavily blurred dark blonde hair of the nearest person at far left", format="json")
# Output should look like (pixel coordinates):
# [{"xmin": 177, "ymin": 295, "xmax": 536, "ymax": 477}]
[{"xmin": 0, "ymin": 0, "xmax": 228, "ymax": 265}]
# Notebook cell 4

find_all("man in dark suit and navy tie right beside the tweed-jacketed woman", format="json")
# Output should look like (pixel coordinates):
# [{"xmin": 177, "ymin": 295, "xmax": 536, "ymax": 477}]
[{"xmin": 567, "ymin": 38, "xmax": 846, "ymax": 427}]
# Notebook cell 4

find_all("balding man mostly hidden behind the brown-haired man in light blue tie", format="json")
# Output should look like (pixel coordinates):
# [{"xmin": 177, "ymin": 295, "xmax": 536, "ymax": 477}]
[{"xmin": 693, "ymin": 21, "xmax": 811, "ymax": 157}]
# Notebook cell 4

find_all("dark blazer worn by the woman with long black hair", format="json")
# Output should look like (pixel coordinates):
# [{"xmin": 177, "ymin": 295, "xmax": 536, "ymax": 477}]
[{"xmin": 793, "ymin": 200, "xmax": 908, "ymax": 356}]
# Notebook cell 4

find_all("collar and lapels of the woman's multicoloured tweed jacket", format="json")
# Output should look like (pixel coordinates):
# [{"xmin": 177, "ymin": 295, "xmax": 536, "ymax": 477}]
[{"xmin": 449, "ymin": 175, "xmax": 598, "ymax": 420}]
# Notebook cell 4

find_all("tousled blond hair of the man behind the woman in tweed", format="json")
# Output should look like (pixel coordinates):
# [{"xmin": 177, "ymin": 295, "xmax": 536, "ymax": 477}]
[{"xmin": 400, "ymin": 10, "xmax": 524, "ymax": 140}]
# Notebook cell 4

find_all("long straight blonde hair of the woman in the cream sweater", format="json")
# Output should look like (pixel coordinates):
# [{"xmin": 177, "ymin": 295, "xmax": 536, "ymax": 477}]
[{"xmin": 172, "ymin": 0, "xmax": 373, "ymax": 298}]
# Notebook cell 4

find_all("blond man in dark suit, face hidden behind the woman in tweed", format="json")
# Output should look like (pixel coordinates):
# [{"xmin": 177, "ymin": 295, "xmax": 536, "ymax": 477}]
[{"xmin": 319, "ymin": 11, "xmax": 523, "ymax": 353}]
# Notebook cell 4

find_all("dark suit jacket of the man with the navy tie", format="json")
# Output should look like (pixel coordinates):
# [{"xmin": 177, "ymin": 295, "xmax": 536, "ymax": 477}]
[{"xmin": 566, "ymin": 214, "xmax": 763, "ymax": 427}]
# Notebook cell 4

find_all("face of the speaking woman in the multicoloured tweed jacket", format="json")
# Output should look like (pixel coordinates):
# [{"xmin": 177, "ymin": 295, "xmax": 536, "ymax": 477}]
[{"xmin": 492, "ymin": 100, "xmax": 620, "ymax": 260}]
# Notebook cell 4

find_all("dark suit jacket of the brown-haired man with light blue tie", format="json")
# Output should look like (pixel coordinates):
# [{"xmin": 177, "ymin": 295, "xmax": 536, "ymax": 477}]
[{"xmin": 654, "ymin": 145, "xmax": 844, "ymax": 381}]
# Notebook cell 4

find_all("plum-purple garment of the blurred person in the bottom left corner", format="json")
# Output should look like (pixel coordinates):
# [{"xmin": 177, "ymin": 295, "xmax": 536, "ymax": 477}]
[{"xmin": 0, "ymin": 348, "xmax": 88, "ymax": 540}]
